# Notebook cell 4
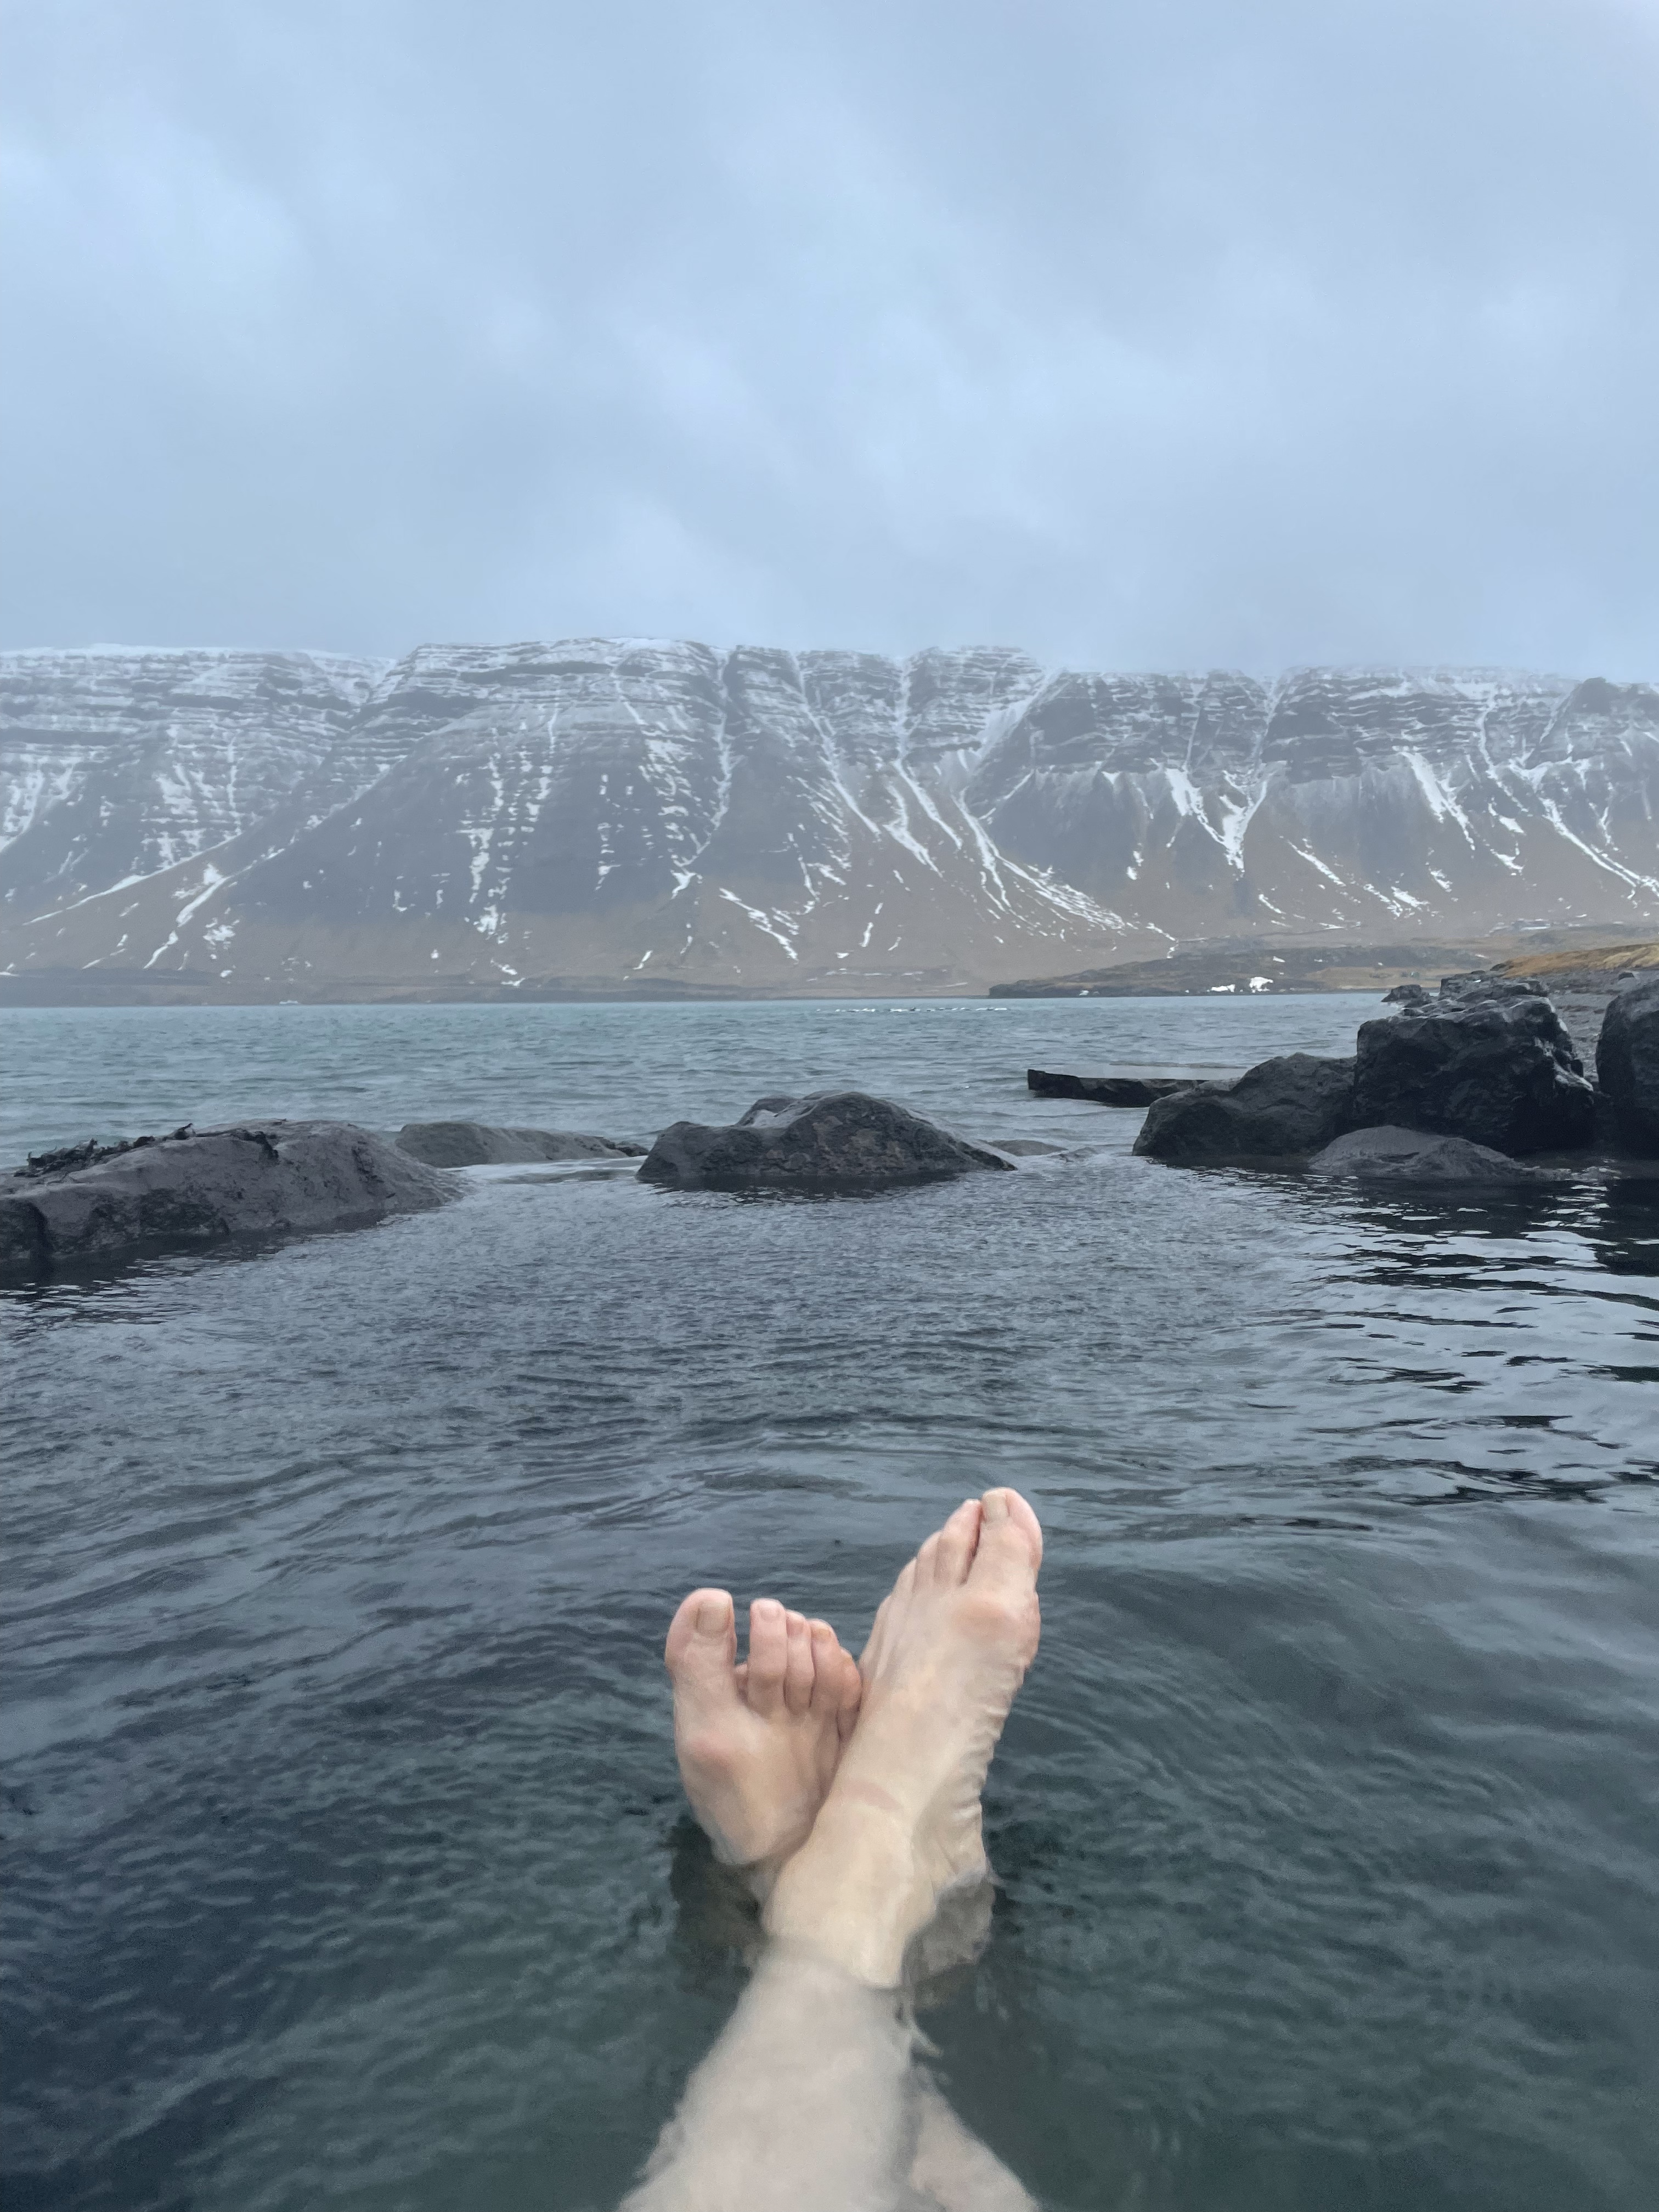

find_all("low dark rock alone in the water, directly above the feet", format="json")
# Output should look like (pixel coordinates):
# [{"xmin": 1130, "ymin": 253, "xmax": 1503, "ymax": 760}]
[{"xmin": 639, "ymin": 1091, "xmax": 1011, "ymax": 1190}]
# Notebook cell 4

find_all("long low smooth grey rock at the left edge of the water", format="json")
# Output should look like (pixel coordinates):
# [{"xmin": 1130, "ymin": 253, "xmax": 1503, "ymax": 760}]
[{"xmin": 0, "ymin": 1121, "xmax": 458, "ymax": 1283}]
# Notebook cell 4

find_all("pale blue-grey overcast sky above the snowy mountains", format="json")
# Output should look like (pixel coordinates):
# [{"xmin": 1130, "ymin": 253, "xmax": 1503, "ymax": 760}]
[{"xmin": 0, "ymin": 0, "xmax": 1659, "ymax": 679}]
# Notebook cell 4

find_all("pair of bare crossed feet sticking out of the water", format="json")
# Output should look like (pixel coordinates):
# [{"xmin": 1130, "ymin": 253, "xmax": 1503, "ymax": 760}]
[{"xmin": 666, "ymin": 1489, "xmax": 1042, "ymax": 1989}]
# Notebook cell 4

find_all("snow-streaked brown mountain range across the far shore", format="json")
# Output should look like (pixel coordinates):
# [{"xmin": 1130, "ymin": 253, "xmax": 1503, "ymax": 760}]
[{"xmin": 0, "ymin": 639, "xmax": 1659, "ymax": 995}]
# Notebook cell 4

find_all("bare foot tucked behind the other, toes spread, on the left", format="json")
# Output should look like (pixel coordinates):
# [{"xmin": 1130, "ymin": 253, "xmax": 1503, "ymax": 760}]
[{"xmin": 664, "ymin": 1590, "xmax": 860, "ymax": 1893}]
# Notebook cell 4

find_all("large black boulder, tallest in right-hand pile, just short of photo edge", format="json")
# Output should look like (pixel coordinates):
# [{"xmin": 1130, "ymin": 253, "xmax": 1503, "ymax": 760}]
[{"xmin": 1352, "ymin": 995, "xmax": 1595, "ymax": 1153}]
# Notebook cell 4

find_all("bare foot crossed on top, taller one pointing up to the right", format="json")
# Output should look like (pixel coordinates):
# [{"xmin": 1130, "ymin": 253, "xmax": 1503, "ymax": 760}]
[{"xmin": 765, "ymin": 1491, "xmax": 1042, "ymax": 1989}]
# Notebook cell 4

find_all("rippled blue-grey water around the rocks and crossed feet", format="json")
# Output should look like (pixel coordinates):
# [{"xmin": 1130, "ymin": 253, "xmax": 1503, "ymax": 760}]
[{"xmin": 4, "ymin": 997, "xmax": 1659, "ymax": 2212}]
